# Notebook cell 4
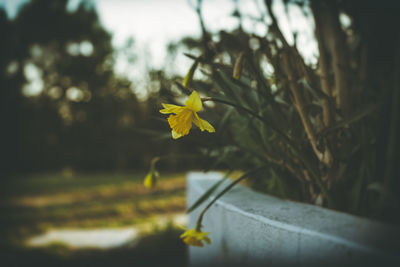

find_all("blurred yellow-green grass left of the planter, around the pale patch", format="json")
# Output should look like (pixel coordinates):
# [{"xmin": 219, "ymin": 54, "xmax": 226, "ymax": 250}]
[{"xmin": 0, "ymin": 173, "xmax": 186, "ymax": 266}]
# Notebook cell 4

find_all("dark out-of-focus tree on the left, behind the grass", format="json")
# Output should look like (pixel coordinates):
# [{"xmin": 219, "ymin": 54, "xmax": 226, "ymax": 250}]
[{"xmin": 0, "ymin": 0, "xmax": 143, "ymax": 174}]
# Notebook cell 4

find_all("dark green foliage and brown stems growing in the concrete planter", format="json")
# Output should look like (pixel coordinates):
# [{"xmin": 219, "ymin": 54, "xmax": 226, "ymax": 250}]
[{"xmin": 156, "ymin": 0, "xmax": 400, "ymax": 224}]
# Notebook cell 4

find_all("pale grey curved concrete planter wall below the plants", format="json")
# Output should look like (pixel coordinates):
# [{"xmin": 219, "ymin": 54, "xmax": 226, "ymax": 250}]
[{"xmin": 187, "ymin": 172, "xmax": 400, "ymax": 266}]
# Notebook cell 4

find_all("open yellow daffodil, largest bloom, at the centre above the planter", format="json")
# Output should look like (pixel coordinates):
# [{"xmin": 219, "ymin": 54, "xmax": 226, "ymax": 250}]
[{"xmin": 160, "ymin": 91, "xmax": 215, "ymax": 139}]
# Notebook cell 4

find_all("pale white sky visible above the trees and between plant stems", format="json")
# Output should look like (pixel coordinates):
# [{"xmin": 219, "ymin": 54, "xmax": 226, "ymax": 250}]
[{"xmin": 0, "ymin": 0, "xmax": 317, "ymax": 99}]
